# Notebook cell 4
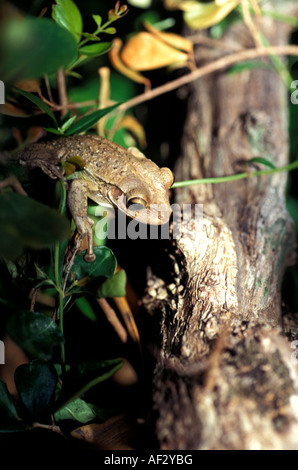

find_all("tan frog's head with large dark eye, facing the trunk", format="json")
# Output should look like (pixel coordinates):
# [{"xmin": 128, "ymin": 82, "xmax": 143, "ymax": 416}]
[{"xmin": 109, "ymin": 163, "xmax": 174, "ymax": 225}]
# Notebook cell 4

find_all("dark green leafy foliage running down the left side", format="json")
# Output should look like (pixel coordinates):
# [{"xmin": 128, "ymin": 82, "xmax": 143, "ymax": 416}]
[{"xmin": 0, "ymin": 0, "xmax": 132, "ymax": 433}]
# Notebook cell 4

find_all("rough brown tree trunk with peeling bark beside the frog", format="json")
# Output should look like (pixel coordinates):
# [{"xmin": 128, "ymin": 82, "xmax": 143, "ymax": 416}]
[{"xmin": 144, "ymin": 1, "xmax": 298, "ymax": 450}]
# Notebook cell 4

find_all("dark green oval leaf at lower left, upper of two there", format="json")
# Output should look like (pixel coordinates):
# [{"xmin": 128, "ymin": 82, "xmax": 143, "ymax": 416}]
[{"xmin": 6, "ymin": 310, "xmax": 64, "ymax": 360}]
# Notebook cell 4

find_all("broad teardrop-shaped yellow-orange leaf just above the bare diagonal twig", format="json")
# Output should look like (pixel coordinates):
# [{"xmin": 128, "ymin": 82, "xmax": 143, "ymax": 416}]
[{"xmin": 121, "ymin": 32, "xmax": 188, "ymax": 70}]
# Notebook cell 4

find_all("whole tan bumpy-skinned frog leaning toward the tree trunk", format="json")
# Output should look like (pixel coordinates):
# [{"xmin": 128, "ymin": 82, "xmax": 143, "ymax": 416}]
[{"xmin": 17, "ymin": 135, "xmax": 174, "ymax": 262}]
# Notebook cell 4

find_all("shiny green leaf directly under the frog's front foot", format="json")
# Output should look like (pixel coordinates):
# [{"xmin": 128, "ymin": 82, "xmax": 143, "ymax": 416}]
[{"xmin": 70, "ymin": 246, "xmax": 117, "ymax": 280}]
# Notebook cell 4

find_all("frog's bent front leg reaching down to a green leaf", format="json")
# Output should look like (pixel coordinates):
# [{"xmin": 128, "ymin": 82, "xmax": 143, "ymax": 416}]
[{"xmin": 68, "ymin": 179, "xmax": 97, "ymax": 263}]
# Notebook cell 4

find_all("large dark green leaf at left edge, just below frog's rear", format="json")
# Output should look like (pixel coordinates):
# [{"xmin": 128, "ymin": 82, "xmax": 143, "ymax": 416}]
[{"xmin": 0, "ymin": 192, "xmax": 70, "ymax": 259}]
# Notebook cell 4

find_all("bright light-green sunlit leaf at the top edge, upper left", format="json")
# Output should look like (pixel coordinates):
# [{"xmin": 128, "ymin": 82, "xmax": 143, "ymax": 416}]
[{"xmin": 52, "ymin": 0, "xmax": 83, "ymax": 42}]
